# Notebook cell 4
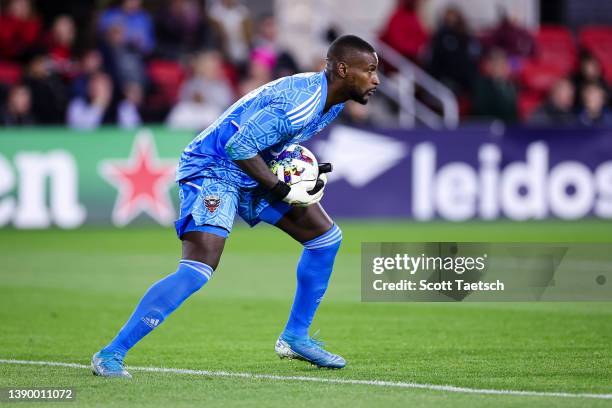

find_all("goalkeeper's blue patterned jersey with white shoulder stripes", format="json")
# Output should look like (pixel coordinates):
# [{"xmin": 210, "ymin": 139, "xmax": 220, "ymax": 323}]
[{"xmin": 176, "ymin": 72, "xmax": 344, "ymax": 188}]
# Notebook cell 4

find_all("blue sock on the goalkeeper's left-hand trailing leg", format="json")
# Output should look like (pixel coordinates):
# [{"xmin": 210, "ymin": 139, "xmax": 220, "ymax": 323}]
[{"xmin": 103, "ymin": 259, "xmax": 213, "ymax": 356}]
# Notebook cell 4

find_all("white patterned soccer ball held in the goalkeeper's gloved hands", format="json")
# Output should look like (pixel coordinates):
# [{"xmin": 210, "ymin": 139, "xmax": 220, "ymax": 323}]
[{"xmin": 268, "ymin": 144, "xmax": 319, "ymax": 190}]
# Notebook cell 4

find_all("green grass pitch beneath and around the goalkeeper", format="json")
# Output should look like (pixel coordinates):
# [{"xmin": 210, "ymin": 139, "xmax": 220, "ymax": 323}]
[{"xmin": 0, "ymin": 220, "xmax": 612, "ymax": 407}]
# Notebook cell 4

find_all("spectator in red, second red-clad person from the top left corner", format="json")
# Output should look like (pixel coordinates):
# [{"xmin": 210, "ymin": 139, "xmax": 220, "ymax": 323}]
[{"xmin": 46, "ymin": 14, "xmax": 76, "ymax": 78}]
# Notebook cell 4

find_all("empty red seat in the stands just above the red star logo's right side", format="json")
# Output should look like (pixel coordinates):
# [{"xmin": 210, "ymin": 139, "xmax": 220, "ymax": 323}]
[{"xmin": 147, "ymin": 60, "xmax": 185, "ymax": 108}]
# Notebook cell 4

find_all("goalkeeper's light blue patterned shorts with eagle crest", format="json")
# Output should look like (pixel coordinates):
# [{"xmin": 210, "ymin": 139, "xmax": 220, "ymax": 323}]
[{"xmin": 174, "ymin": 177, "xmax": 291, "ymax": 238}]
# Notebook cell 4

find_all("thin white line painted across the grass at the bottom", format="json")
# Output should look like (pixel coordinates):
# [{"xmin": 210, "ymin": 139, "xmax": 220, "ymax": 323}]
[{"xmin": 0, "ymin": 359, "xmax": 612, "ymax": 400}]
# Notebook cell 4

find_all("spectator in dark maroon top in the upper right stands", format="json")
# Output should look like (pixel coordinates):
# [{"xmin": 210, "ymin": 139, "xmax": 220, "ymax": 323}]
[{"xmin": 482, "ymin": 12, "xmax": 535, "ymax": 60}]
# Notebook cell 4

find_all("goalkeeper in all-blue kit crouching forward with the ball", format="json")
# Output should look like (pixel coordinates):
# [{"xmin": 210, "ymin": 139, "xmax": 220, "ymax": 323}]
[{"xmin": 91, "ymin": 35, "xmax": 379, "ymax": 377}]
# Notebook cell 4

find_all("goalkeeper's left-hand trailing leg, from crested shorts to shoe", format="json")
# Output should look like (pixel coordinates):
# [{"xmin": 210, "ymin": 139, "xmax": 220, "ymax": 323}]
[{"xmin": 92, "ymin": 177, "xmax": 236, "ymax": 377}]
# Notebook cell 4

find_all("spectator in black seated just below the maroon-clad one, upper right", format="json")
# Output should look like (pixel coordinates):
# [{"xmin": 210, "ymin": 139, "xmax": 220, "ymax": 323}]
[{"xmin": 472, "ymin": 50, "xmax": 518, "ymax": 122}]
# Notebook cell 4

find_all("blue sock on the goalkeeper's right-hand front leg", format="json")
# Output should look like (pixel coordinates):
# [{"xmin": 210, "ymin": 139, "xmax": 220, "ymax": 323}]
[{"xmin": 283, "ymin": 224, "xmax": 342, "ymax": 337}]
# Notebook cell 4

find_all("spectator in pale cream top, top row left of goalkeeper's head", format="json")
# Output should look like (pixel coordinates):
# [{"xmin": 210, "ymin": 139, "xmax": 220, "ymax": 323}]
[{"xmin": 210, "ymin": 0, "xmax": 252, "ymax": 67}]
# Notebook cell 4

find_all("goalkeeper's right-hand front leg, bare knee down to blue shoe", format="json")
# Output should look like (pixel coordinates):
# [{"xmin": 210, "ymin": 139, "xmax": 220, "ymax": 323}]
[{"xmin": 264, "ymin": 204, "xmax": 346, "ymax": 368}]
